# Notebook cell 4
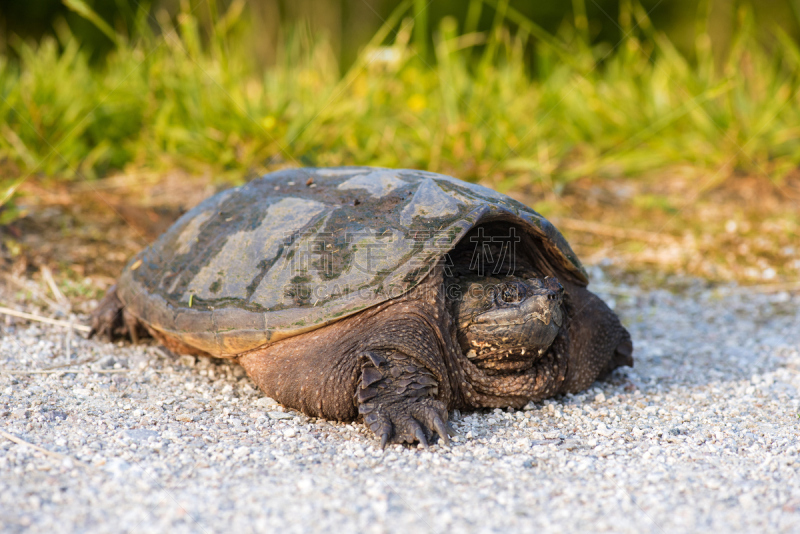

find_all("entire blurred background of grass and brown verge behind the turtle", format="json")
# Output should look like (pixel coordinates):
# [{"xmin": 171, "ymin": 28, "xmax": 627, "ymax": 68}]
[{"xmin": 0, "ymin": 0, "xmax": 800, "ymax": 280}]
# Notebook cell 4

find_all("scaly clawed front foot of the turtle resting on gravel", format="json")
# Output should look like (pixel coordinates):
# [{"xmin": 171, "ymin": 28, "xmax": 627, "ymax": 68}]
[{"xmin": 355, "ymin": 350, "xmax": 453, "ymax": 448}]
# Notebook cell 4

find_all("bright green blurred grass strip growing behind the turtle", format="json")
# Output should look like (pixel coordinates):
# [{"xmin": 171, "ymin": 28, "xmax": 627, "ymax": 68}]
[{"xmin": 0, "ymin": 0, "xmax": 800, "ymax": 224}]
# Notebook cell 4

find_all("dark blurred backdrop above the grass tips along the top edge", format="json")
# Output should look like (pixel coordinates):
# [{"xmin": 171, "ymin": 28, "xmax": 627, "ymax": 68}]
[{"xmin": 0, "ymin": 0, "xmax": 800, "ymax": 68}]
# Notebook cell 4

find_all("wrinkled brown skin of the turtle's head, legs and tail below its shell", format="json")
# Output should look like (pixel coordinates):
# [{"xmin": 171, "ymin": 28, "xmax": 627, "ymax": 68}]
[{"xmin": 92, "ymin": 267, "xmax": 633, "ymax": 446}]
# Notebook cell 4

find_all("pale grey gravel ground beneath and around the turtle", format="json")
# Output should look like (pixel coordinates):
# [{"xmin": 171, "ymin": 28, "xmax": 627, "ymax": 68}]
[{"xmin": 0, "ymin": 272, "xmax": 800, "ymax": 532}]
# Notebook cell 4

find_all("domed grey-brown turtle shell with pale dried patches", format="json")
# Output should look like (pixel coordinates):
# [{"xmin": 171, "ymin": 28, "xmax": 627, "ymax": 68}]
[{"xmin": 117, "ymin": 167, "xmax": 587, "ymax": 357}]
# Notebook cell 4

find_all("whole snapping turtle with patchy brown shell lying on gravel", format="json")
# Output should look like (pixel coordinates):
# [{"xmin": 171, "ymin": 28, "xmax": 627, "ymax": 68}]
[{"xmin": 92, "ymin": 167, "xmax": 633, "ymax": 446}]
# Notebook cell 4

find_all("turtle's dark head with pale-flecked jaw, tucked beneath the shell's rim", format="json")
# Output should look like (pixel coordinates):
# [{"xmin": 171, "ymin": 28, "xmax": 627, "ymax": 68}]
[{"xmin": 448, "ymin": 276, "xmax": 566, "ymax": 370}]
